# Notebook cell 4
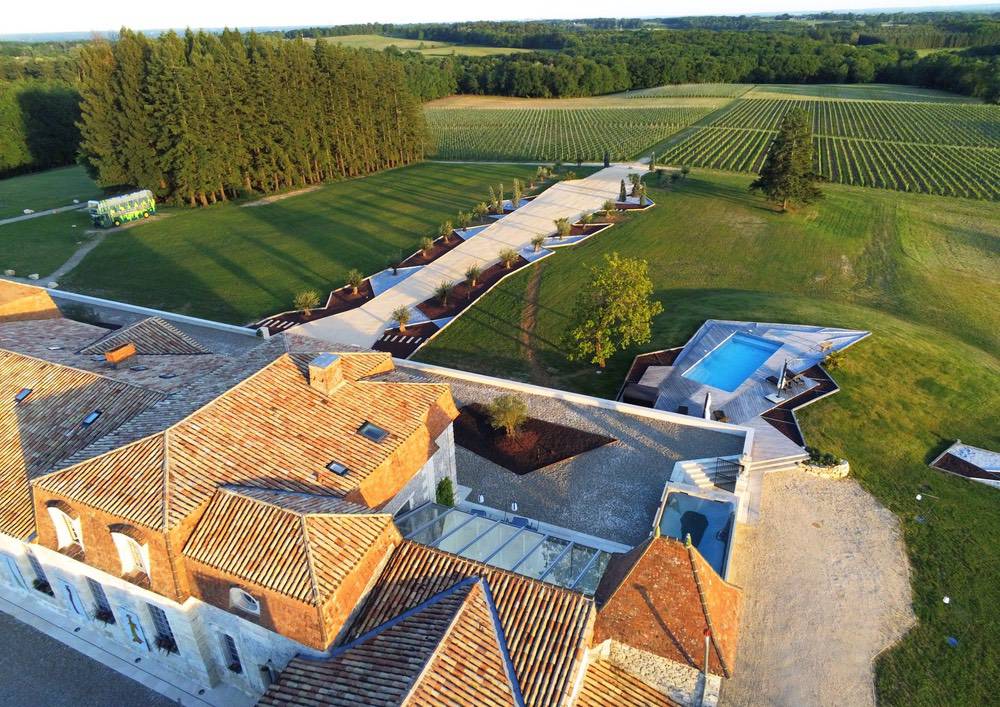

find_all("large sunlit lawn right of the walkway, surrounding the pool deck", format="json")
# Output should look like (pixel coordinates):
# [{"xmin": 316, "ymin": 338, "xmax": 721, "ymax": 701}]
[{"xmin": 418, "ymin": 170, "xmax": 1000, "ymax": 705}]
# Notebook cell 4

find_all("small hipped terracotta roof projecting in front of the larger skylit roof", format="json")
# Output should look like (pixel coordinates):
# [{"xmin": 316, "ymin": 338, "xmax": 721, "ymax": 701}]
[{"xmin": 183, "ymin": 489, "xmax": 392, "ymax": 606}]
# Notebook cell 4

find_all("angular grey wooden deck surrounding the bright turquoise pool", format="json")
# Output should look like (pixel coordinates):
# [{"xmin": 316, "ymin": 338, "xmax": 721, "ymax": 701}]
[{"xmin": 639, "ymin": 319, "xmax": 869, "ymax": 424}]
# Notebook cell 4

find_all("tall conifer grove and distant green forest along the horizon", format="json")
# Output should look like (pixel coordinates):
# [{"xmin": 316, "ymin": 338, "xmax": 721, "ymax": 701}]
[{"xmin": 0, "ymin": 12, "xmax": 1000, "ymax": 180}]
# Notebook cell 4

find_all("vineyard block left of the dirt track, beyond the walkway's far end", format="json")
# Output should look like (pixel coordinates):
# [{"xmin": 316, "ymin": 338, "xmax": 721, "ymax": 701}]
[{"xmin": 426, "ymin": 106, "xmax": 710, "ymax": 162}]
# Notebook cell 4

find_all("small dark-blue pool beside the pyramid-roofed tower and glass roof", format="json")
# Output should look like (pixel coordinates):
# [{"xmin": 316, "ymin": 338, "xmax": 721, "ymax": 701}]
[{"xmin": 660, "ymin": 491, "xmax": 736, "ymax": 577}]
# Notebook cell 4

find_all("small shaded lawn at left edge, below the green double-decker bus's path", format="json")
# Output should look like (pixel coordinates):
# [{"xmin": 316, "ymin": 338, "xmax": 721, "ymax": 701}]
[{"xmin": 0, "ymin": 211, "xmax": 92, "ymax": 278}]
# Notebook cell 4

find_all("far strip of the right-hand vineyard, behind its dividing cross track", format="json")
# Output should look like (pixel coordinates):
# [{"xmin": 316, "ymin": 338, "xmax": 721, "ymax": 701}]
[{"xmin": 710, "ymin": 99, "xmax": 1000, "ymax": 147}]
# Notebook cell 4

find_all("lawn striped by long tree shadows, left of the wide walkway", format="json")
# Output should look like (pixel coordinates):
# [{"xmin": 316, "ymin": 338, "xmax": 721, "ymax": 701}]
[{"xmin": 62, "ymin": 163, "xmax": 548, "ymax": 324}]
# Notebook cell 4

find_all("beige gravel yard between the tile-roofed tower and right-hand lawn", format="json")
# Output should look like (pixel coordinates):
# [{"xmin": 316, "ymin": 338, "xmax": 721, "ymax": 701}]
[{"xmin": 722, "ymin": 472, "xmax": 914, "ymax": 706}]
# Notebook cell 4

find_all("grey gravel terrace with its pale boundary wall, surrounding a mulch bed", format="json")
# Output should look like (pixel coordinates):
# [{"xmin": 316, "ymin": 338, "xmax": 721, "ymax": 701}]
[{"xmin": 388, "ymin": 361, "xmax": 746, "ymax": 545}]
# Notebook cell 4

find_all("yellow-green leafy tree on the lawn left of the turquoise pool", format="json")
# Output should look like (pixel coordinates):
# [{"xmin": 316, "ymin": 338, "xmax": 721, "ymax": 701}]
[{"xmin": 562, "ymin": 253, "xmax": 663, "ymax": 368}]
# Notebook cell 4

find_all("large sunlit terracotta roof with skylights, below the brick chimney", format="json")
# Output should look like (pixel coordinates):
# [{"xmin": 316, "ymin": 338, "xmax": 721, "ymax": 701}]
[{"xmin": 37, "ymin": 353, "xmax": 457, "ymax": 529}]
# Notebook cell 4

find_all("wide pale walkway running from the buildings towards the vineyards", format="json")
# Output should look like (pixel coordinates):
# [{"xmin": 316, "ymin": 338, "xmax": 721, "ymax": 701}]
[{"xmin": 289, "ymin": 164, "xmax": 647, "ymax": 348}]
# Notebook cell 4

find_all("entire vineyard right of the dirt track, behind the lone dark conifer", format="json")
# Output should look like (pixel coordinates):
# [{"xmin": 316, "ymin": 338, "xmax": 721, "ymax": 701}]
[{"xmin": 660, "ymin": 99, "xmax": 1000, "ymax": 199}]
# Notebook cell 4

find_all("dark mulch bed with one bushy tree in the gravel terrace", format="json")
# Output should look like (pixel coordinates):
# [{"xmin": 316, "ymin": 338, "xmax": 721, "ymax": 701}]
[{"xmin": 455, "ymin": 403, "xmax": 616, "ymax": 476}]
